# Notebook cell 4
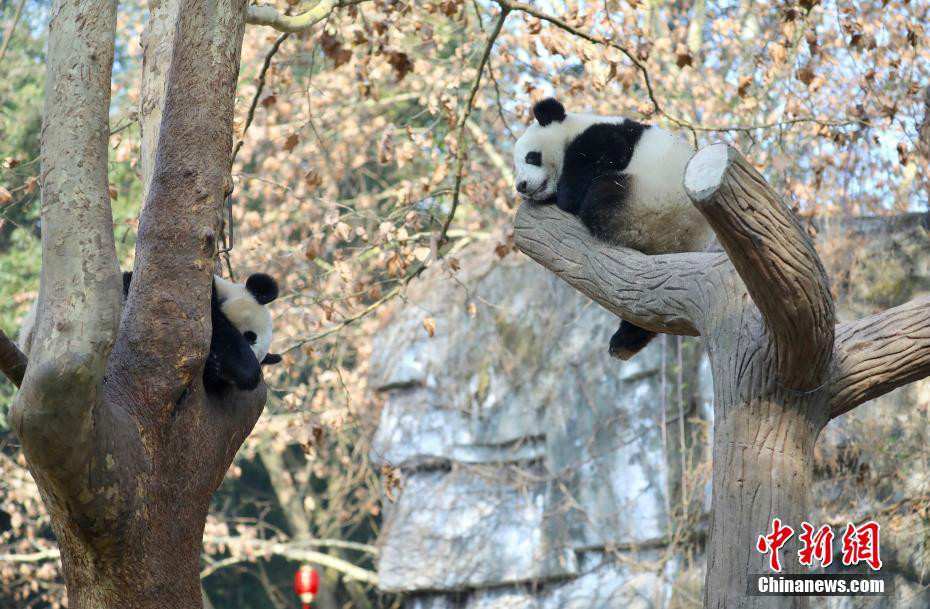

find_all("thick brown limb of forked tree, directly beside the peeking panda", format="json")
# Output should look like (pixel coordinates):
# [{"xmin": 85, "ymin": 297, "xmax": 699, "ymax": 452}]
[{"xmin": 111, "ymin": 0, "xmax": 246, "ymax": 402}]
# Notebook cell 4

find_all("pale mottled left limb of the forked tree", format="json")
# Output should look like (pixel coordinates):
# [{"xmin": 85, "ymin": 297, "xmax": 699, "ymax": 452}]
[{"xmin": 11, "ymin": 0, "xmax": 122, "ymax": 466}]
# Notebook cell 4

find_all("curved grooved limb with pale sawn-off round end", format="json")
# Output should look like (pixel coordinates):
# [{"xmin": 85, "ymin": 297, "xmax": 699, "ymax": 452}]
[{"xmin": 685, "ymin": 144, "xmax": 836, "ymax": 390}]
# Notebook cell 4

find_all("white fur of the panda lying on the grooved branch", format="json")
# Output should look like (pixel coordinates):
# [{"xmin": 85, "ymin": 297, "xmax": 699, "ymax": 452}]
[{"xmin": 513, "ymin": 112, "xmax": 714, "ymax": 254}]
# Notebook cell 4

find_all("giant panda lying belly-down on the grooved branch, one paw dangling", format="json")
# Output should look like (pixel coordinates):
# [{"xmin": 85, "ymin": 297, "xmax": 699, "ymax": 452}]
[{"xmin": 513, "ymin": 98, "xmax": 714, "ymax": 360}]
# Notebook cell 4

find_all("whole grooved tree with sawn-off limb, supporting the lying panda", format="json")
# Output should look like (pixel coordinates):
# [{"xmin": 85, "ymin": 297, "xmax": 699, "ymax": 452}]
[{"xmin": 515, "ymin": 144, "xmax": 930, "ymax": 609}]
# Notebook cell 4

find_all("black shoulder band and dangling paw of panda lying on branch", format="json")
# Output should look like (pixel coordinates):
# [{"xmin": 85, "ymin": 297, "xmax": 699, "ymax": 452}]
[{"xmin": 556, "ymin": 117, "xmax": 656, "ymax": 360}]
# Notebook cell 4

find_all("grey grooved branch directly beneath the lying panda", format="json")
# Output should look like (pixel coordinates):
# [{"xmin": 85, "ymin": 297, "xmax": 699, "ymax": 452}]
[{"xmin": 514, "ymin": 203, "xmax": 716, "ymax": 336}]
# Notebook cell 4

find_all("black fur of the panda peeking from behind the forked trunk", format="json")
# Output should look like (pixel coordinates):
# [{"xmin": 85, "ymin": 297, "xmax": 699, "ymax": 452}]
[{"xmin": 123, "ymin": 271, "xmax": 272, "ymax": 394}]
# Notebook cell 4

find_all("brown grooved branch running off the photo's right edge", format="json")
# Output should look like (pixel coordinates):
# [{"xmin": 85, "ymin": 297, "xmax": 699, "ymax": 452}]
[{"xmin": 830, "ymin": 297, "xmax": 930, "ymax": 417}]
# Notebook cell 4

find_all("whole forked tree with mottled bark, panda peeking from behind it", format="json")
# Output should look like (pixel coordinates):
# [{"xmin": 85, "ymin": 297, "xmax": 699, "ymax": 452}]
[{"xmin": 0, "ymin": 0, "xmax": 265, "ymax": 609}]
